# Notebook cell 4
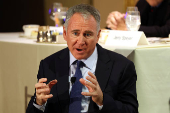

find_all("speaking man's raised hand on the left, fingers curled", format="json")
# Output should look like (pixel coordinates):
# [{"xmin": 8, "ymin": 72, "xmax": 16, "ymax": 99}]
[{"xmin": 35, "ymin": 78, "xmax": 57, "ymax": 105}]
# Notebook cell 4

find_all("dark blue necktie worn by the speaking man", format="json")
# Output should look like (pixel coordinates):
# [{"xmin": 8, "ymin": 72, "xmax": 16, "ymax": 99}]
[{"xmin": 69, "ymin": 61, "xmax": 84, "ymax": 113}]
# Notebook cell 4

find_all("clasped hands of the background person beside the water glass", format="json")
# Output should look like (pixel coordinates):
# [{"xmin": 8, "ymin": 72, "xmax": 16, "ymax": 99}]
[{"xmin": 106, "ymin": 11, "xmax": 127, "ymax": 30}]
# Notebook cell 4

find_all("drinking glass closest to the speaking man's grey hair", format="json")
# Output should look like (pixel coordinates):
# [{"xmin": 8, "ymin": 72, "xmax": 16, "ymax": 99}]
[{"xmin": 55, "ymin": 7, "xmax": 68, "ymax": 27}]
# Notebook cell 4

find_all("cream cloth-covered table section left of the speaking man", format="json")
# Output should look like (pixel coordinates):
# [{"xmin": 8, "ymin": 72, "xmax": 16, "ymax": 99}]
[{"xmin": 0, "ymin": 33, "xmax": 66, "ymax": 113}]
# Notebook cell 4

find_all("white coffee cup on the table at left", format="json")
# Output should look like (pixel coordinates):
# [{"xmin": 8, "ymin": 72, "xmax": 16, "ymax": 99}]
[{"xmin": 23, "ymin": 24, "xmax": 39, "ymax": 36}]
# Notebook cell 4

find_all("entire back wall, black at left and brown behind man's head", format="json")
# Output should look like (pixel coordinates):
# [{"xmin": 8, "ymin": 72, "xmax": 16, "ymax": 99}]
[{"xmin": 0, "ymin": 0, "xmax": 138, "ymax": 32}]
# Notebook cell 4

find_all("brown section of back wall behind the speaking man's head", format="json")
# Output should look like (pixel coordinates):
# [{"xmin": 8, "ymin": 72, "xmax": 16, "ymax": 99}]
[{"xmin": 44, "ymin": 0, "xmax": 125, "ymax": 28}]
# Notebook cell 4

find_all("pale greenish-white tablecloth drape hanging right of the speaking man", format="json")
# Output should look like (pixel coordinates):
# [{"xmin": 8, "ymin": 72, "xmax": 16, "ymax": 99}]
[{"xmin": 128, "ymin": 46, "xmax": 170, "ymax": 113}]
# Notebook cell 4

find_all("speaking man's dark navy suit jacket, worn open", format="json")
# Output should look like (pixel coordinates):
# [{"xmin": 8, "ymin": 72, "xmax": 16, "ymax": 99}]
[{"xmin": 26, "ymin": 44, "xmax": 138, "ymax": 113}]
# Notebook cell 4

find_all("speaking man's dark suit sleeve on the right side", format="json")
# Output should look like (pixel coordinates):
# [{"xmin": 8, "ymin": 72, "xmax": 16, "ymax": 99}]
[{"xmin": 101, "ymin": 62, "xmax": 138, "ymax": 113}]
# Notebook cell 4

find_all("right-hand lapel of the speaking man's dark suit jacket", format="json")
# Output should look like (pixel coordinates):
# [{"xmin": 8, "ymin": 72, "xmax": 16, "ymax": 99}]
[{"xmin": 89, "ymin": 44, "xmax": 113, "ymax": 112}]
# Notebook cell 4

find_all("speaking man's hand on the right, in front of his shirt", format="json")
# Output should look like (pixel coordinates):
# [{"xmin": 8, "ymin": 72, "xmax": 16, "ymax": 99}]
[{"xmin": 80, "ymin": 72, "xmax": 103, "ymax": 106}]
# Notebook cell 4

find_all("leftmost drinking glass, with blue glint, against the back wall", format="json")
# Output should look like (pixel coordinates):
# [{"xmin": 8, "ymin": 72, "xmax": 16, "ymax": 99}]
[{"xmin": 48, "ymin": 2, "xmax": 62, "ymax": 21}]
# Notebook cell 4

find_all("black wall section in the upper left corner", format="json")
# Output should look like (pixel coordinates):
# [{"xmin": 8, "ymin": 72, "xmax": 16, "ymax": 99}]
[{"xmin": 0, "ymin": 0, "xmax": 45, "ymax": 32}]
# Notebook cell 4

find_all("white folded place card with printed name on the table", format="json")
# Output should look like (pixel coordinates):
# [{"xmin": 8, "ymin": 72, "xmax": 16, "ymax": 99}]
[{"xmin": 102, "ymin": 30, "xmax": 149, "ymax": 47}]
